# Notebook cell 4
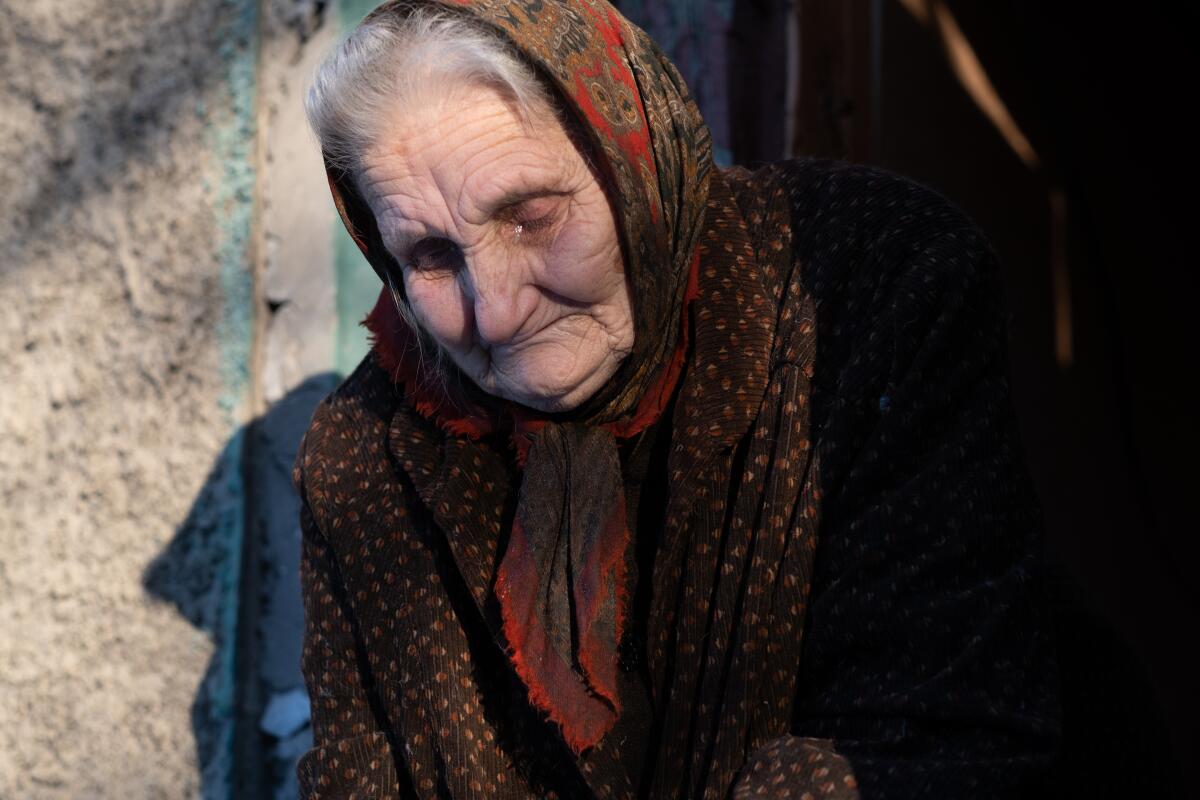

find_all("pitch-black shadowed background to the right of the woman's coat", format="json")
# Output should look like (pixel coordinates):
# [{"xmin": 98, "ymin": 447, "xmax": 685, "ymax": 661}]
[{"xmin": 871, "ymin": 0, "xmax": 1198, "ymax": 777}]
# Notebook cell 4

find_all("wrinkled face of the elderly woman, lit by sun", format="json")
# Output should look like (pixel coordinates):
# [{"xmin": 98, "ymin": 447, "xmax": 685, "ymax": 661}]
[{"xmin": 359, "ymin": 88, "xmax": 634, "ymax": 411}]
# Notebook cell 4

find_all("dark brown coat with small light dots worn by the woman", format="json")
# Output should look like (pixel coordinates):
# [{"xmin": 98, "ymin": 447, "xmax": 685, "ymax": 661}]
[{"xmin": 294, "ymin": 160, "xmax": 1060, "ymax": 799}]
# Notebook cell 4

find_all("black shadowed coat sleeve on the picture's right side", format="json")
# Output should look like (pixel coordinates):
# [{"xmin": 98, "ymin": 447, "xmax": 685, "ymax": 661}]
[{"xmin": 792, "ymin": 213, "xmax": 1060, "ymax": 799}]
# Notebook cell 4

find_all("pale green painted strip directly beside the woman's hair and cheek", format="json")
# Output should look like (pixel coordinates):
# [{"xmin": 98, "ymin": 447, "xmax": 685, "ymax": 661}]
[{"xmin": 334, "ymin": 0, "xmax": 380, "ymax": 375}]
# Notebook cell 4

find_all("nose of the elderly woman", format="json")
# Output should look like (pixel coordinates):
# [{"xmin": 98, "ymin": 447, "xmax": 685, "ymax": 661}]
[{"xmin": 463, "ymin": 251, "xmax": 536, "ymax": 349}]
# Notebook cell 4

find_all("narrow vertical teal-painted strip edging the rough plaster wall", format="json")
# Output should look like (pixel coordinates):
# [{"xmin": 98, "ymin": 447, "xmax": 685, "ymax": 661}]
[{"xmin": 196, "ymin": 0, "xmax": 259, "ymax": 799}]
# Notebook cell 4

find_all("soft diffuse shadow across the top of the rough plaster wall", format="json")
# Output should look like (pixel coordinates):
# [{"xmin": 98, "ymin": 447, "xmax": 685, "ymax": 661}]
[{"xmin": 0, "ymin": 0, "xmax": 329, "ymax": 281}]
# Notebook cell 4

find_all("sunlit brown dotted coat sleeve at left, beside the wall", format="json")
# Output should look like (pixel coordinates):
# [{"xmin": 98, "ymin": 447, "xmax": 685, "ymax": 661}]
[{"xmin": 293, "ymin": 417, "xmax": 400, "ymax": 799}]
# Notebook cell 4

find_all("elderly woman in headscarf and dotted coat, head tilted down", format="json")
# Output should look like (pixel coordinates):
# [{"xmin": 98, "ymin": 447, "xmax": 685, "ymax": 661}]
[{"xmin": 295, "ymin": 0, "xmax": 1058, "ymax": 798}]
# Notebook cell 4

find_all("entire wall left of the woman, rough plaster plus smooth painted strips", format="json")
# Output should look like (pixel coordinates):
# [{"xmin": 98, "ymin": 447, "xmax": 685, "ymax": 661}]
[{"xmin": 0, "ymin": 0, "xmax": 408, "ymax": 799}]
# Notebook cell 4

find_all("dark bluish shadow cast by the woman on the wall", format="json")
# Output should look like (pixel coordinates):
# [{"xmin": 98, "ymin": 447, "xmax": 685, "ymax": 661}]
[{"xmin": 142, "ymin": 373, "xmax": 340, "ymax": 800}]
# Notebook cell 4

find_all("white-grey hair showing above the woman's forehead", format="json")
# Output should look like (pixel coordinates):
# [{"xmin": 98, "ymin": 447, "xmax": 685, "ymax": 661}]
[{"xmin": 305, "ymin": 6, "xmax": 562, "ymax": 178}]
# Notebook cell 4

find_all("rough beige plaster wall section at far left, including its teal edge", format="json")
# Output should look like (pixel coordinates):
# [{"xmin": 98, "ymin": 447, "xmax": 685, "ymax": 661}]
[{"xmin": 0, "ymin": 0, "xmax": 258, "ymax": 799}]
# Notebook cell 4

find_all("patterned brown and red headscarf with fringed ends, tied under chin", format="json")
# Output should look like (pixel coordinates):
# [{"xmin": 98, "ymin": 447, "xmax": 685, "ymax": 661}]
[{"xmin": 326, "ymin": 0, "xmax": 712, "ymax": 753}]
